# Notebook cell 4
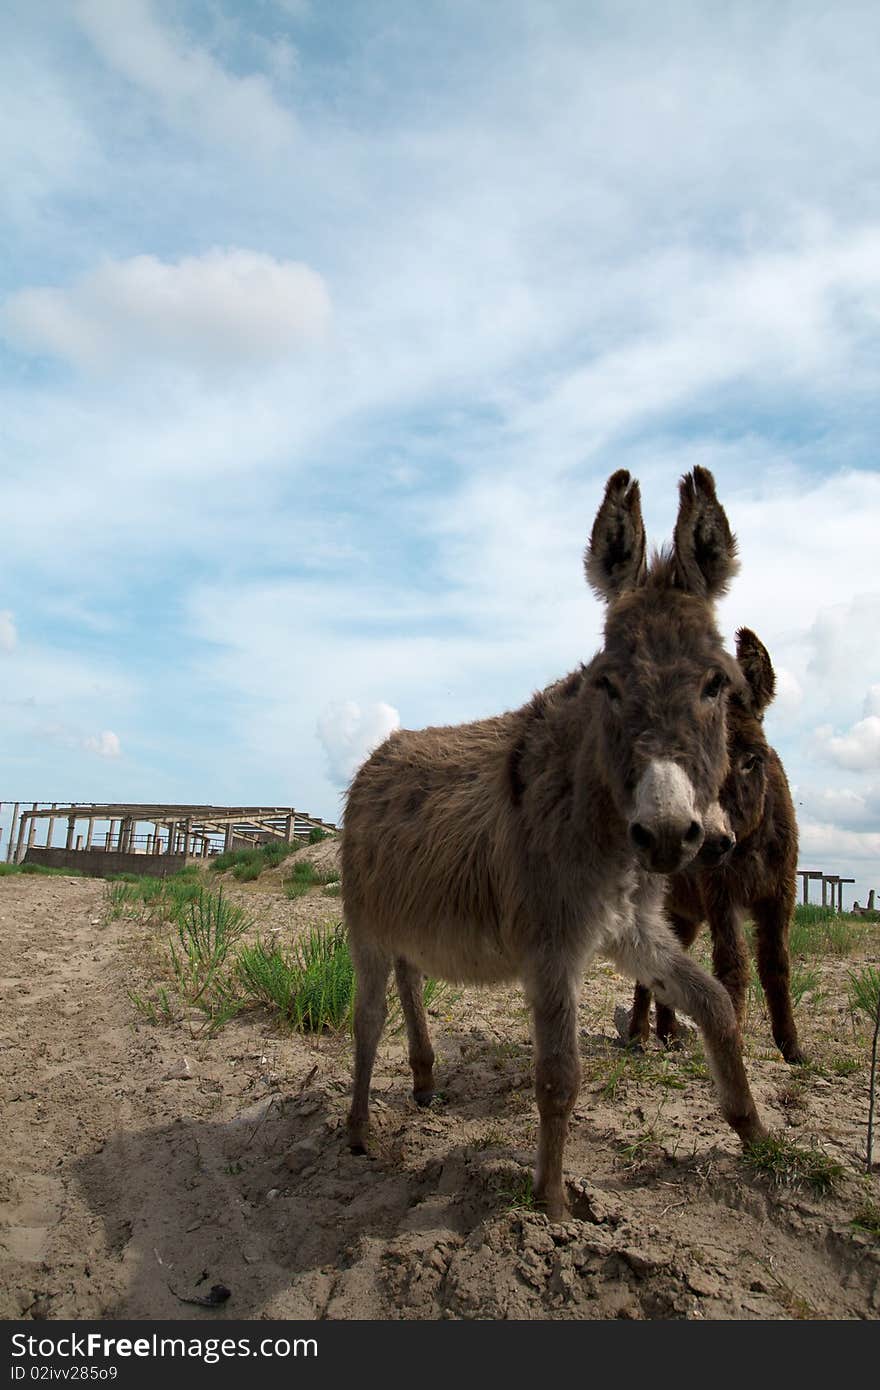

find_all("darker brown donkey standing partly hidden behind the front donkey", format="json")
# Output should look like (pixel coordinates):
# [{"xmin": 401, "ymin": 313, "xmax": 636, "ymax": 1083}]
[{"xmin": 630, "ymin": 627, "xmax": 806, "ymax": 1062}]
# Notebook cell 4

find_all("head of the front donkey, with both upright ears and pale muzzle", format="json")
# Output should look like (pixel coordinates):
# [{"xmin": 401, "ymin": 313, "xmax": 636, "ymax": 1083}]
[{"xmin": 584, "ymin": 468, "xmax": 742, "ymax": 873}]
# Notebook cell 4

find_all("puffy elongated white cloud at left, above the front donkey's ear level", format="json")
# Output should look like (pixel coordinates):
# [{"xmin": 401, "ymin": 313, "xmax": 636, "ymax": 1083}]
[{"xmin": 0, "ymin": 247, "xmax": 329, "ymax": 367}]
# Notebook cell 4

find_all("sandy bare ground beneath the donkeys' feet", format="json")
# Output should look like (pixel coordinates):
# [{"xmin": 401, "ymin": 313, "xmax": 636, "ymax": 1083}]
[{"xmin": 0, "ymin": 847, "xmax": 880, "ymax": 1322}]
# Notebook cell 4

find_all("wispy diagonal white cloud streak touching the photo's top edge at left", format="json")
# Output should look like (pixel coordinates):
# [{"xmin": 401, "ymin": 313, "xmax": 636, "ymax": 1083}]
[{"xmin": 76, "ymin": 0, "xmax": 296, "ymax": 157}]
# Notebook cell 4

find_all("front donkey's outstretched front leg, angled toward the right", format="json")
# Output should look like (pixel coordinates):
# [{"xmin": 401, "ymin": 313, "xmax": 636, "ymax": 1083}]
[{"xmin": 609, "ymin": 922, "xmax": 766, "ymax": 1144}]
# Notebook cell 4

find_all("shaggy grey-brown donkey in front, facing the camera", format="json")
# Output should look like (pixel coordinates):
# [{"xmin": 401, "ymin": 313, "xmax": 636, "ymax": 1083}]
[{"xmin": 342, "ymin": 468, "xmax": 763, "ymax": 1219}]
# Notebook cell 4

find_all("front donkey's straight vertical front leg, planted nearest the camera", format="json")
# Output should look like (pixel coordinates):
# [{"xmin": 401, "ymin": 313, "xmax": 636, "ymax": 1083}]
[{"xmin": 531, "ymin": 983, "xmax": 581, "ymax": 1220}]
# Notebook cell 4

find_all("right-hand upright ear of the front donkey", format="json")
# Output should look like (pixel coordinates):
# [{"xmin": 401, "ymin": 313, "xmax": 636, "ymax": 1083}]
[{"xmin": 674, "ymin": 468, "xmax": 740, "ymax": 599}]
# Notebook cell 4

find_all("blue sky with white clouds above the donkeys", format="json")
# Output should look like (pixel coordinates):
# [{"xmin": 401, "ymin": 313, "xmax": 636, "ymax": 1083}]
[{"xmin": 0, "ymin": 0, "xmax": 880, "ymax": 902}]
